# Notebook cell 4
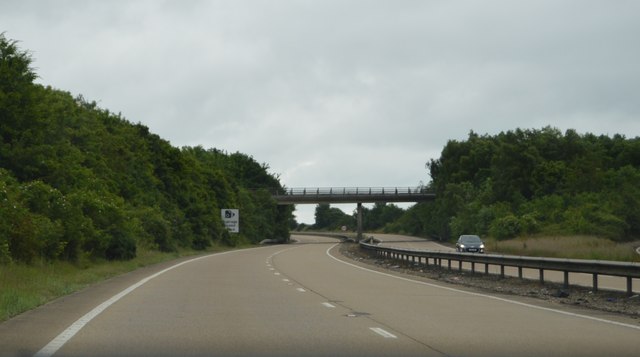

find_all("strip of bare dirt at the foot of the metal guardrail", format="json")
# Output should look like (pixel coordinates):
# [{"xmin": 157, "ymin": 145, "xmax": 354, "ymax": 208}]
[{"xmin": 340, "ymin": 243, "xmax": 640, "ymax": 319}]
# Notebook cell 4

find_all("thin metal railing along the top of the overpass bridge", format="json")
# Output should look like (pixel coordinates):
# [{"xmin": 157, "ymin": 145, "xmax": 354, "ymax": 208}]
[{"xmin": 276, "ymin": 187, "xmax": 431, "ymax": 196}]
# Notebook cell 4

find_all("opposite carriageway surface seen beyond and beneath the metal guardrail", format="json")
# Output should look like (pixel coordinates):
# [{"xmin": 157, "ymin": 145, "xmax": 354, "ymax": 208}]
[{"xmin": 367, "ymin": 234, "xmax": 640, "ymax": 293}]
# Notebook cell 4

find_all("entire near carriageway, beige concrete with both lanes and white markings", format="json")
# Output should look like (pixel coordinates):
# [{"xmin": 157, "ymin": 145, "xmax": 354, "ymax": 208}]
[{"xmin": 0, "ymin": 236, "xmax": 640, "ymax": 356}]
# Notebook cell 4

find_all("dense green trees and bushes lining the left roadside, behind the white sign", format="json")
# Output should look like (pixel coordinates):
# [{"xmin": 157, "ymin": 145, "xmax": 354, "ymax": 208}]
[{"xmin": 0, "ymin": 34, "xmax": 292, "ymax": 262}]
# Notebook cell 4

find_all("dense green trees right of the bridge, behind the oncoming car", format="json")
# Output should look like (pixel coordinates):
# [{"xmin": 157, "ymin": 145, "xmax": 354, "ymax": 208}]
[{"xmin": 388, "ymin": 127, "xmax": 640, "ymax": 241}]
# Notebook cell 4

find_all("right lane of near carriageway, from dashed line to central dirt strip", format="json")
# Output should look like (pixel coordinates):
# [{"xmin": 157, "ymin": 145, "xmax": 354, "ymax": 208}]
[{"xmin": 276, "ymin": 235, "xmax": 640, "ymax": 356}]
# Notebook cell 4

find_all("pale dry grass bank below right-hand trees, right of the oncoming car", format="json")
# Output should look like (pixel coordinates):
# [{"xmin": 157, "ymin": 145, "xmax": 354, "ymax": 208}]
[{"xmin": 486, "ymin": 236, "xmax": 640, "ymax": 262}]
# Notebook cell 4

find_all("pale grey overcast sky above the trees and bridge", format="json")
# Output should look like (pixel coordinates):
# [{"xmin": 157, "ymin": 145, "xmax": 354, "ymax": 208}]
[{"xmin": 0, "ymin": 0, "xmax": 640, "ymax": 223}]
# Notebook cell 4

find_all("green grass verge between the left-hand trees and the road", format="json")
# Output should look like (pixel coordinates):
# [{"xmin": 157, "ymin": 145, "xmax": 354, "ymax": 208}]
[{"xmin": 0, "ymin": 246, "xmax": 248, "ymax": 322}]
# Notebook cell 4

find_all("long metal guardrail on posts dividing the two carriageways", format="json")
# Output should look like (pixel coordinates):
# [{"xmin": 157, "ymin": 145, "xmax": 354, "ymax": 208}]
[{"xmin": 360, "ymin": 241, "xmax": 640, "ymax": 296}]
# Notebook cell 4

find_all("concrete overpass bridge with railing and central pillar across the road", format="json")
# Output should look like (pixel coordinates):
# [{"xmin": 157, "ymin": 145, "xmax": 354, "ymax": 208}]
[{"xmin": 273, "ymin": 187, "xmax": 436, "ymax": 241}]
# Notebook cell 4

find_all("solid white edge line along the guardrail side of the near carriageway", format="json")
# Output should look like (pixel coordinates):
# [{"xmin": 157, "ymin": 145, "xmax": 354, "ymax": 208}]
[{"xmin": 326, "ymin": 243, "xmax": 640, "ymax": 330}]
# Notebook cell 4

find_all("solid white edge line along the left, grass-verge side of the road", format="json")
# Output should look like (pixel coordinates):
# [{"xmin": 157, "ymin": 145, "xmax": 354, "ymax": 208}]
[{"xmin": 34, "ymin": 250, "xmax": 243, "ymax": 357}]
